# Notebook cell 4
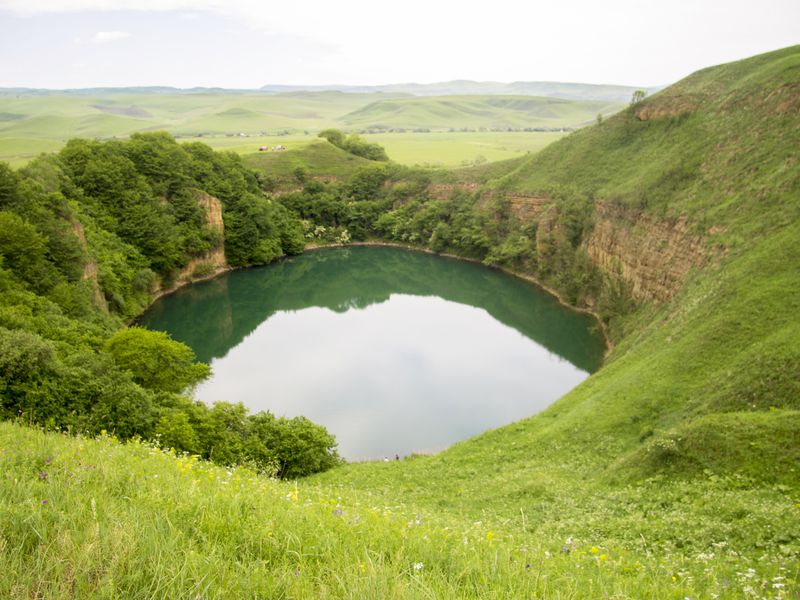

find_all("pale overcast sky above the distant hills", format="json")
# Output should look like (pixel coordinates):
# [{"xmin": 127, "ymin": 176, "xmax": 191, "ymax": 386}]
[{"xmin": 0, "ymin": 0, "xmax": 800, "ymax": 88}]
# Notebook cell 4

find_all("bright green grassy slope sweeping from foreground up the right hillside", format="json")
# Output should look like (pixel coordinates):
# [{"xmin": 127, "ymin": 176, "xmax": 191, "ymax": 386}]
[{"xmin": 0, "ymin": 47, "xmax": 800, "ymax": 598}]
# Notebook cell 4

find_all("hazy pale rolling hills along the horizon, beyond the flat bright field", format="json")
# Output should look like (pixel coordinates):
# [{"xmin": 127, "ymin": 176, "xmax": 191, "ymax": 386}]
[{"xmin": 0, "ymin": 88, "xmax": 623, "ymax": 165}]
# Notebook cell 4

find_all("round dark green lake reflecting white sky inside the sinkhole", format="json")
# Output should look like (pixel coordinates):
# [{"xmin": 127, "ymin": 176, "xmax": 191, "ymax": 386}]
[{"xmin": 139, "ymin": 247, "xmax": 605, "ymax": 460}]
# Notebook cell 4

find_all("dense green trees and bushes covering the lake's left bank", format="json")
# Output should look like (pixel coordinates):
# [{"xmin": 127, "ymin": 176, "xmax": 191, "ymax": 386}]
[{"xmin": 0, "ymin": 133, "xmax": 339, "ymax": 477}]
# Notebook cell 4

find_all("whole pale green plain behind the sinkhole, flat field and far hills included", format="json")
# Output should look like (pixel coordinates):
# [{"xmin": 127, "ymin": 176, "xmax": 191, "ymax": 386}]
[{"xmin": 0, "ymin": 92, "xmax": 622, "ymax": 166}]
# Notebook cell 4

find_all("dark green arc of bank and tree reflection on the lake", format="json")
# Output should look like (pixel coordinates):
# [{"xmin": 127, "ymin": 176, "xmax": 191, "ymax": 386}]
[{"xmin": 141, "ymin": 247, "xmax": 604, "ymax": 372}]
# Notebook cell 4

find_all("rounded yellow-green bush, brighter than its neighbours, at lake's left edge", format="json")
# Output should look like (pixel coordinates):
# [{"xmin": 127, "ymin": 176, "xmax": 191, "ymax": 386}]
[{"xmin": 106, "ymin": 327, "xmax": 211, "ymax": 394}]
